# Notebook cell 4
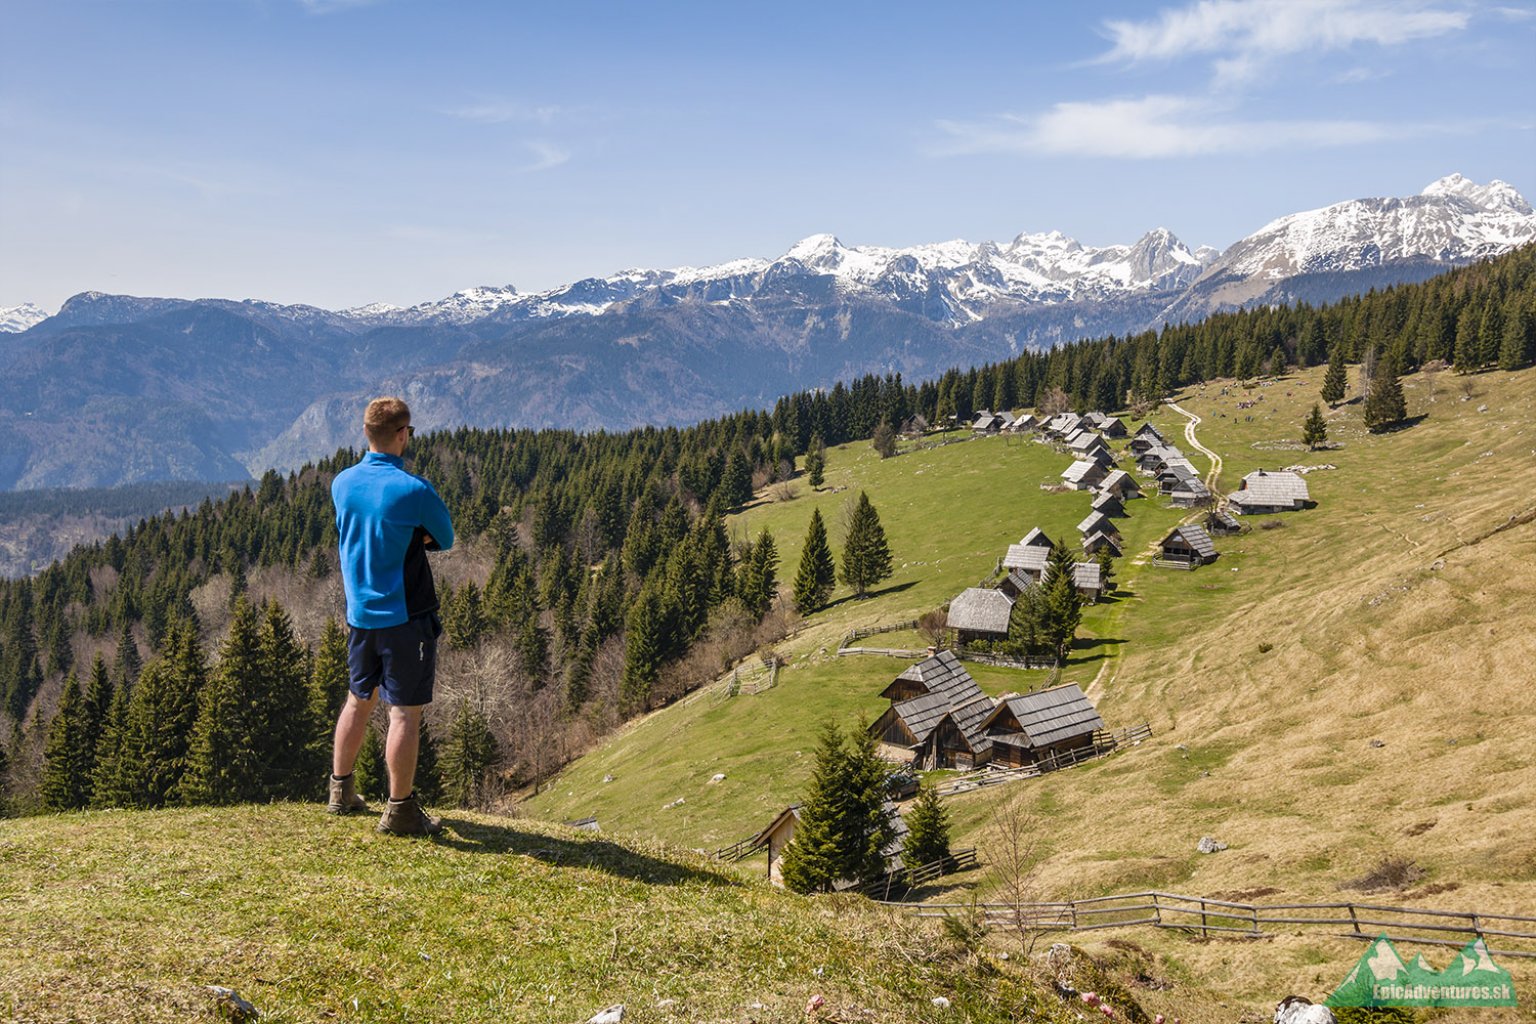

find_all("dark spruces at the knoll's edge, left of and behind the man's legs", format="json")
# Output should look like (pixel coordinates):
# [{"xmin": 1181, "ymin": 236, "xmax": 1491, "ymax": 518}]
[{"xmin": 38, "ymin": 599, "xmax": 495, "ymax": 811}]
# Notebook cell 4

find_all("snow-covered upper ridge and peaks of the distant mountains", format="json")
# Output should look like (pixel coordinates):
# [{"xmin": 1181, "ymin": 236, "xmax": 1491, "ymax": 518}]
[{"xmin": 0, "ymin": 173, "xmax": 1536, "ymax": 332}]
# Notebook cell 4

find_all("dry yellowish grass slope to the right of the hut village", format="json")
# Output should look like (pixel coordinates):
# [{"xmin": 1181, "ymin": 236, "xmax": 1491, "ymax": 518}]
[{"xmin": 933, "ymin": 372, "xmax": 1536, "ymax": 1021}]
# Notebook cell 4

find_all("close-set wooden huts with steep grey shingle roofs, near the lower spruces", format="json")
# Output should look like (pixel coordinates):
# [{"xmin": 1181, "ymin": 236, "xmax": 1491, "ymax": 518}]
[{"xmin": 869, "ymin": 651, "xmax": 1104, "ymax": 769}]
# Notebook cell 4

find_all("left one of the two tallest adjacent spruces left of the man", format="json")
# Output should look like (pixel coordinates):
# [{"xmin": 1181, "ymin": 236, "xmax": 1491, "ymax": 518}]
[{"xmin": 180, "ymin": 596, "xmax": 266, "ymax": 804}]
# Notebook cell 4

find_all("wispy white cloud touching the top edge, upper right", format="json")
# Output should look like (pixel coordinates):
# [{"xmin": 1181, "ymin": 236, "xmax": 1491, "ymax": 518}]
[{"xmin": 1100, "ymin": 0, "xmax": 1470, "ymax": 84}]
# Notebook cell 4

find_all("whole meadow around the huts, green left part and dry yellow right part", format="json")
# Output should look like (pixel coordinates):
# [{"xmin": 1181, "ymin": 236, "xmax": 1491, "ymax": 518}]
[{"xmin": 525, "ymin": 368, "xmax": 1536, "ymax": 1019}]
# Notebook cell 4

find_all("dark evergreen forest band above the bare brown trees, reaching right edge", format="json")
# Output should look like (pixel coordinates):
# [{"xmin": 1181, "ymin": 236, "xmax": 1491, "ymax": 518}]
[{"xmin": 0, "ymin": 247, "xmax": 1536, "ymax": 810}]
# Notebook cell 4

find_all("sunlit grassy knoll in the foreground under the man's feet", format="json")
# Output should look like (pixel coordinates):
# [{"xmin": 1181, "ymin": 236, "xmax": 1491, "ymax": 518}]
[{"xmin": 0, "ymin": 804, "xmax": 1087, "ymax": 1022}]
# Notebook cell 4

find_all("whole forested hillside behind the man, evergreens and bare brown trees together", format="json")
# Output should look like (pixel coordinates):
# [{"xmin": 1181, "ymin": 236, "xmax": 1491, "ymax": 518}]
[{"xmin": 0, "ymin": 249, "xmax": 1536, "ymax": 811}]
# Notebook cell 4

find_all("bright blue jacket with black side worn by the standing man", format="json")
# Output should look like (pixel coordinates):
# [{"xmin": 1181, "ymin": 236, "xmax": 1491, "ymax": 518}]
[{"xmin": 330, "ymin": 451, "xmax": 453, "ymax": 629}]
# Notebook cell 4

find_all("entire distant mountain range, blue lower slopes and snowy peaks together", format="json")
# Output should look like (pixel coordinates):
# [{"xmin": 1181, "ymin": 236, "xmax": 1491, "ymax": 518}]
[{"xmin": 0, "ymin": 175, "xmax": 1536, "ymax": 488}]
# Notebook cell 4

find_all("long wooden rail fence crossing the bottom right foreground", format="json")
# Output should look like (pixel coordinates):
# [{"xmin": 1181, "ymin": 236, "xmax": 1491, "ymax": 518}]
[{"xmin": 883, "ymin": 892, "xmax": 1536, "ymax": 958}]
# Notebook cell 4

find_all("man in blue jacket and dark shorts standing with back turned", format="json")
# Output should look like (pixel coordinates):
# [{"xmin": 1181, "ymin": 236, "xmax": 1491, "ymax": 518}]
[{"xmin": 327, "ymin": 398, "xmax": 453, "ymax": 835}]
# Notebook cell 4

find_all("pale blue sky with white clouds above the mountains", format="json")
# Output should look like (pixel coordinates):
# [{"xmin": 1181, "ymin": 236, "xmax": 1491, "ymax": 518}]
[{"xmin": 0, "ymin": 0, "xmax": 1536, "ymax": 309}]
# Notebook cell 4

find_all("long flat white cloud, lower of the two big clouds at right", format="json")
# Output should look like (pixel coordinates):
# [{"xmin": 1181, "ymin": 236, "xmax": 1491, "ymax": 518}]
[{"xmin": 938, "ymin": 95, "xmax": 1432, "ymax": 160}]
